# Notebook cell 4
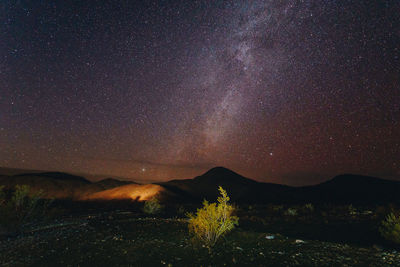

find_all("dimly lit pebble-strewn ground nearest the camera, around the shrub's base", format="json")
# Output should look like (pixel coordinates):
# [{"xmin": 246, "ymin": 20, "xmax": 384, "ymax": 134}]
[{"xmin": 0, "ymin": 212, "xmax": 400, "ymax": 266}]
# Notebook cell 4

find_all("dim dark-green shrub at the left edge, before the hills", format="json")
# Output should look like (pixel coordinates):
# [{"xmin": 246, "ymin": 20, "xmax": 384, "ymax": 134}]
[{"xmin": 0, "ymin": 185, "xmax": 50, "ymax": 233}]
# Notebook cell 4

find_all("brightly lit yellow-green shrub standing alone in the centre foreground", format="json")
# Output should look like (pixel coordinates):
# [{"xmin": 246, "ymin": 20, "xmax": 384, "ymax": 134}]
[{"xmin": 187, "ymin": 186, "xmax": 239, "ymax": 248}]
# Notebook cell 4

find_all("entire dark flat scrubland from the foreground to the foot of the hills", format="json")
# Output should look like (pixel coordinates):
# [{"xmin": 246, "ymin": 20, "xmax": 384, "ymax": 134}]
[{"xmin": 0, "ymin": 205, "xmax": 400, "ymax": 266}]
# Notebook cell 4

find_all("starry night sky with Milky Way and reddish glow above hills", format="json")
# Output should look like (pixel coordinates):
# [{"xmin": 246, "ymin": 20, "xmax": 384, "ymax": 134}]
[{"xmin": 0, "ymin": 0, "xmax": 400, "ymax": 185}]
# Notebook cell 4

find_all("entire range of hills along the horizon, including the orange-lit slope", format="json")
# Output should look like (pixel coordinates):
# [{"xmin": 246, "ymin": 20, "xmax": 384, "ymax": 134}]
[{"xmin": 0, "ymin": 167, "xmax": 400, "ymax": 204}]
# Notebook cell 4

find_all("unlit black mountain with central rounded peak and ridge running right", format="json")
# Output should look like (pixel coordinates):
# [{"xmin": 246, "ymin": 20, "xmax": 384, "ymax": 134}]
[{"xmin": 159, "ymin": 167, "xmax": 400, "ymax": 203}]
